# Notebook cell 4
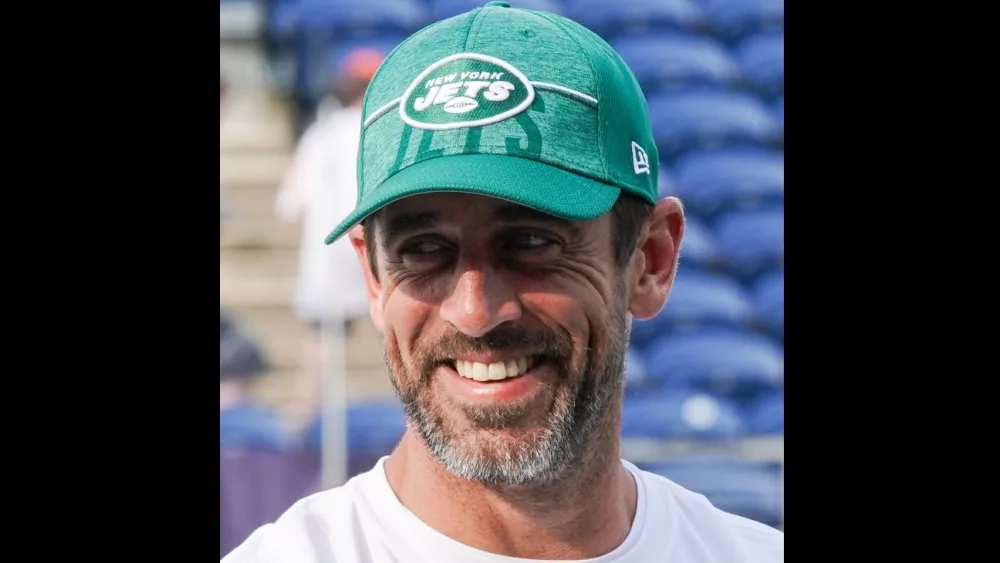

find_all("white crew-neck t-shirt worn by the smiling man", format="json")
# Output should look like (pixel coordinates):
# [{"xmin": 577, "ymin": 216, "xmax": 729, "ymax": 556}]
[{"xmin": 222, "ymin": 458, "xmax": 785, "ymax": 563}]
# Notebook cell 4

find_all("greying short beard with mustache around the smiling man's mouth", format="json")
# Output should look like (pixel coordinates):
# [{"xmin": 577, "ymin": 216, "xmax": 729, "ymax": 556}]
[{"xmin": 385, "ymin": 298, "xmax": 629, "ymax": 486}]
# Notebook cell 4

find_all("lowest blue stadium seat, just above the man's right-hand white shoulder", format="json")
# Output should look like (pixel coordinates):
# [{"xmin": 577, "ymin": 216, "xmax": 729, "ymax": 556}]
[{"xmin": 647, "ymin": 460, "xmax": 782, "ymax": 526}]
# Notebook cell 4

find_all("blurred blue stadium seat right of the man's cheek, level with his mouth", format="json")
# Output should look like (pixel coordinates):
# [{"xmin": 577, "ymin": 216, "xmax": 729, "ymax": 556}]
[{"xmin": 647, "ymin": 328, "xmax": 785, "ymax": 401}]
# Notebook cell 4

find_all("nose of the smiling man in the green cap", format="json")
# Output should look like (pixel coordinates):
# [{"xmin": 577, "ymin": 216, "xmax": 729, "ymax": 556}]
[{"xmin": 441, "ymin": 267, "xmax": 521, "ymax": 338}]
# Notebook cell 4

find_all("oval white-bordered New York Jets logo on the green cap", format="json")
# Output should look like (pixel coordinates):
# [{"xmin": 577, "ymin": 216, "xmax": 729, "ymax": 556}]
[{"xmin": 399, "ymin": 53, "xmax": 535, "ymax": 130}]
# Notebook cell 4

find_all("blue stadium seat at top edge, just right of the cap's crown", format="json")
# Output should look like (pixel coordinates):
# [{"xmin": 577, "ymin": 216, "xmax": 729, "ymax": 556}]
[{"xmin": 564, "ymin": 0, "xmax": 702, "ymax": 39}]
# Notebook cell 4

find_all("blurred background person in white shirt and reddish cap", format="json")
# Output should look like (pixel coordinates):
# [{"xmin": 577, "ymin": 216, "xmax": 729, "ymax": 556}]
[{"xmin": 275, "ymin": 49, "xmax": 383, "ymax": 426}]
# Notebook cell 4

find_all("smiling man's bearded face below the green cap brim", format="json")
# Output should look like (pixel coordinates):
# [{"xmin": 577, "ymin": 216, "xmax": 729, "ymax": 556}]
[{"xmin": 366, "ymin": 194, "xmax": 629, "ymax": 484}]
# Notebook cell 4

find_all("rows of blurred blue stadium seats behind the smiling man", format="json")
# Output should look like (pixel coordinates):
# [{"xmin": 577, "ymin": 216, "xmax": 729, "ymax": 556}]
[{"xmin": 223, "ymin": 0, "xmax": 784, "ymax": 552}]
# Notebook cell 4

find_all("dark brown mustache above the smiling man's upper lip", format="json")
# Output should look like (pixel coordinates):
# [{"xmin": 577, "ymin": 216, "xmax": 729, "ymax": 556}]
[{"xmin": 417, "ymin": 326, "xmax": 573, "ymax": 376}]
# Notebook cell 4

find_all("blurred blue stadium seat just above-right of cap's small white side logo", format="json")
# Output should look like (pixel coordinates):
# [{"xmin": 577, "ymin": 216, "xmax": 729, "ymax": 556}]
[{"xmin": 648, "ymin": 89, "xmax": 781, "ymax": 165}]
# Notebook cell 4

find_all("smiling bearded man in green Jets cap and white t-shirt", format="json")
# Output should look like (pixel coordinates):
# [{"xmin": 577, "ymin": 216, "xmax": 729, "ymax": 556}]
[{"xmin": 224, "ymin": 2, "xmax": 784, "ymax": 563}]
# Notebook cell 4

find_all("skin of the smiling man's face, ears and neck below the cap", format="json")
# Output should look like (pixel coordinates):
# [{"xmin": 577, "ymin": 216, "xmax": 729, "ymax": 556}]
[{"xmin": 348, "ymin": 194, "xmax": 684, "ymax": 560}]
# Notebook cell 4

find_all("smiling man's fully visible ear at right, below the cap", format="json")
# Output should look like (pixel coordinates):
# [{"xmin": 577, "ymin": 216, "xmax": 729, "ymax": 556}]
[{"xmin": 629, "ymin": 197, "xmax": 684, "ymax": 320}]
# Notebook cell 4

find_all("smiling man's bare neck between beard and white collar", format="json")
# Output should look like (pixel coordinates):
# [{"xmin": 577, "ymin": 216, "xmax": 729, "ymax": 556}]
[{"xmin": 385, "ymin": 420, "xmax": 636, "ymax": 559}]
